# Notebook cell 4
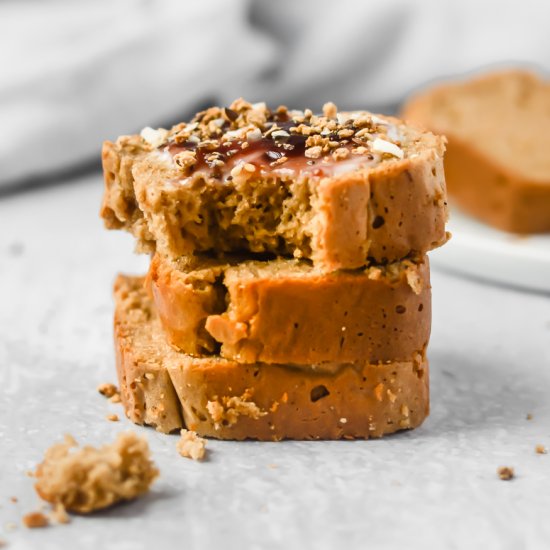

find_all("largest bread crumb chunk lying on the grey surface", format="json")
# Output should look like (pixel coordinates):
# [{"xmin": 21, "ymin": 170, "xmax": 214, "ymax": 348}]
[{"xmin": 34, "ymin": 432, "xmax": 159, "ymax": 514}]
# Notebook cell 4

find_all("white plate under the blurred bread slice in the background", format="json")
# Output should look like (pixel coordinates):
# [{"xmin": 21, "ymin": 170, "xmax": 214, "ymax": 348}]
[{"xmin": 430, "ymin": 207, "xmax": 550, "ymax": 292}]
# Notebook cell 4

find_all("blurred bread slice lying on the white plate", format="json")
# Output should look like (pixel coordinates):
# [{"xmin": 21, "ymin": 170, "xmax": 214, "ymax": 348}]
[{"xmin": 403, "ymin": 70, "xmax": 550, "ymax": 233}]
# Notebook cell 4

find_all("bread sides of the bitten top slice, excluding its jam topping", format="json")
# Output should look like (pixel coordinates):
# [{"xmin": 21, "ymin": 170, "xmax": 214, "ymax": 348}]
[{"xmin": 101, "ymin": 110, "xmax": 448, "ymax": 272}]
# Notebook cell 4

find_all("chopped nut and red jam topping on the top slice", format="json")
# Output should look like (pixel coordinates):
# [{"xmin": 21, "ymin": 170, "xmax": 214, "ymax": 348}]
[{"xmin": 160, "ymin": 99, "xmax": 405, "ymax": 181}]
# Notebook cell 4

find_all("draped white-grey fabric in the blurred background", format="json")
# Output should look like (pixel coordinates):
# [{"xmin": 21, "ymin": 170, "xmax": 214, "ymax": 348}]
[{"xmin": 0, "ymin": 0, "xmax": 550, "ymax": 186}]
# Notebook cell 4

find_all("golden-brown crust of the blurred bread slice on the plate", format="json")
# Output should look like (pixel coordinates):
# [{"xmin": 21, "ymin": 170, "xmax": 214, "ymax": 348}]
[{"xmin": 402, "ymin": 70, "xmax": 550, "ymax": 233}]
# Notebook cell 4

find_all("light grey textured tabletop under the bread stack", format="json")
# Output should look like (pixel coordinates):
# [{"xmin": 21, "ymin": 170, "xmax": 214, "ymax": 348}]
[{"xmin": 0, "ymin": 176, "xmax": 550, "ymax": 550}]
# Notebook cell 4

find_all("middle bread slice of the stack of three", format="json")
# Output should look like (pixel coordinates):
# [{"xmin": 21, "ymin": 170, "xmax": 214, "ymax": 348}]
[{"xmin": 147, "ymin": 254, "xmax": 431, "ymax": 365}]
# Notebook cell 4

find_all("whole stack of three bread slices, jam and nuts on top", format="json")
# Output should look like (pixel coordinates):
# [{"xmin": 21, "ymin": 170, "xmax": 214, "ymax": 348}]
[{"xmin": 101, "ymin": 100, "xmax": 447, "ymax": 440}]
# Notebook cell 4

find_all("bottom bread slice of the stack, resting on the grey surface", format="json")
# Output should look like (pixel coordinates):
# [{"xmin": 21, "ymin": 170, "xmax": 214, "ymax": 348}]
[{"xmin": 115, "ymin": 276, "xmax": 429, "ymax": 440}]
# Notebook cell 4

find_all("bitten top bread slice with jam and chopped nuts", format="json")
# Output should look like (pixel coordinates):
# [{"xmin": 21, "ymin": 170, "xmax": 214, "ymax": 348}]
[{"xmin": 101, "ymin": 100, "xmax": 447, "ymax": 271}]
